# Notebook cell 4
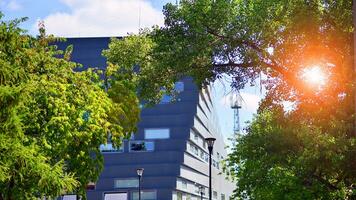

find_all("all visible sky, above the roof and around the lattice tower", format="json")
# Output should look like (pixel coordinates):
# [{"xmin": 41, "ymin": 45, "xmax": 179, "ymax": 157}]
[{"xmin": 0, "ymin": 0, "xmax": 263, "ymax": 146}]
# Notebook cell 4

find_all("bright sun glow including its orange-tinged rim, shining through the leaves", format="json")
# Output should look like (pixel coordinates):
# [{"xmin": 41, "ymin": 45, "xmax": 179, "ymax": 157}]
[{"xmin": 300, "ymin": 65, "xmax": 329, "ymax": 90}]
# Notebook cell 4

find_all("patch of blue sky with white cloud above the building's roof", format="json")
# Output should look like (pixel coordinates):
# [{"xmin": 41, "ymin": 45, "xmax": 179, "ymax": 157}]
[{"xmin": 0, "ymin": 0, "xmax": 175, "ymax": 37}]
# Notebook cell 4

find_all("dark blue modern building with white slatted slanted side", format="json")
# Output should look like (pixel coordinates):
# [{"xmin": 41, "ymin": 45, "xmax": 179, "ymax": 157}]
[{"xmin": 58, "ymin": 38, "xmax": 233, "ymax": 200}]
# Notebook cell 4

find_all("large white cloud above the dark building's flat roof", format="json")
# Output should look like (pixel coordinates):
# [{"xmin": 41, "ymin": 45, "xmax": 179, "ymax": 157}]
[{"xmin": 33, "ymin": 0, "xmax": 163, "ymax": 37}]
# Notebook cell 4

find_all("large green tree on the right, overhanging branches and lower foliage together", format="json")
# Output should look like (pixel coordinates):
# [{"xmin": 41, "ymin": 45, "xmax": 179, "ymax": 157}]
[{"xmin": 107, "ymin": 0, "xmax": 356, "ymax": 199}]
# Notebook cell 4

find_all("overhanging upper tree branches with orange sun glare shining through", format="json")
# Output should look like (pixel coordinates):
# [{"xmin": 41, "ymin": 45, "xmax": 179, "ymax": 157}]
[{"xmin": 106, "ymin": 0, "xmax": 353, "ymax": 104}]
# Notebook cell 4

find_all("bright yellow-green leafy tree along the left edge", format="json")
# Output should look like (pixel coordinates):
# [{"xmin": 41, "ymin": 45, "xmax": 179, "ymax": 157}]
[{"xmin": 0, "ymin": 14, "xmax": 139, "ymax": 200}]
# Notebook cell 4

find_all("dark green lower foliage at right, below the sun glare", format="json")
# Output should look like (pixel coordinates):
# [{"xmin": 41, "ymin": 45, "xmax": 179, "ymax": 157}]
[{"xmin": 225, "ymin": 109, "xmax": 355, "ymax": 199}]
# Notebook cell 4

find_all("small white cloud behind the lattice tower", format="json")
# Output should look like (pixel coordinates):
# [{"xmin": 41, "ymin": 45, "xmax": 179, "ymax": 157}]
[{"xmin": 220, "ymin": 92, "xmax": 261, "ymax": 112}]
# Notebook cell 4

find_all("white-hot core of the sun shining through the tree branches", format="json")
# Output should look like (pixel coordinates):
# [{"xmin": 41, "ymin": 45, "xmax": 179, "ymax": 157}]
[{"xmin": 302, "ymin": 66, "xmax": 327, "ymax": 86}]
